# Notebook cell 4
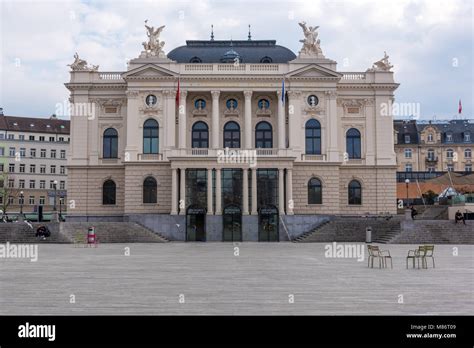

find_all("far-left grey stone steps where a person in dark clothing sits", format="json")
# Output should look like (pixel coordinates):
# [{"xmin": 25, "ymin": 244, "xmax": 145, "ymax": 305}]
[{"xmin": 0, "ymin": 222, "xmax": 72, "ymax": 244}]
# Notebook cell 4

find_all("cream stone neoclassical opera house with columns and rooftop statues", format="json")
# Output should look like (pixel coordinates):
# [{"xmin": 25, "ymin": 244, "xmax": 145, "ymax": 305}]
[{"xmin": 66, "ymin": 24, "xmax": 398, "ymax": 241}]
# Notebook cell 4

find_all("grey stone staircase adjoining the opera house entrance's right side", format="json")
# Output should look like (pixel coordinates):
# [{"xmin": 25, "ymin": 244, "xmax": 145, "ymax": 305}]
[{"xmin": 294, "ymin": 217, "xmax": 400, "ymax": 243}]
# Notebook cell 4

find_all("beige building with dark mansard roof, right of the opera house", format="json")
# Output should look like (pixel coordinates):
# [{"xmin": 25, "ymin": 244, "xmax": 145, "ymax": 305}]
[{"xmin": 394, "ymin": 119, "xmax": 474, "ymax": 172}]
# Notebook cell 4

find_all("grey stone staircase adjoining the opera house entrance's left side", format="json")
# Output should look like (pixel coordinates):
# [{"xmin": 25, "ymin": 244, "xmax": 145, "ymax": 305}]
[{"xmin": 60, "ymin": 222, "xmax": 168, "ymax": 243}]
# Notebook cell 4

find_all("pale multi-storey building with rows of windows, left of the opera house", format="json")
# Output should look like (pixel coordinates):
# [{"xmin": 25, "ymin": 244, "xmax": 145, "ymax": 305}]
[{"xmin": 0, "ymin": 113, "xmax": 69, "ymax": 214}]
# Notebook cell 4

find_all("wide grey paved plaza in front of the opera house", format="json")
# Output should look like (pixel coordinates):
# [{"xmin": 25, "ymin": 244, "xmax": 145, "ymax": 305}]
[{"xmin": 0, "ymin": 242, "xmax": 474, "ymax": 315}]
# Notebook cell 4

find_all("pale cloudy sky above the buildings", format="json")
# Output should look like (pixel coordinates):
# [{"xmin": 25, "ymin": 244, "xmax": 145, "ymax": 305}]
[{"xmin": 0, "ymin": 0, "xmax": 474, "ymax": 119}]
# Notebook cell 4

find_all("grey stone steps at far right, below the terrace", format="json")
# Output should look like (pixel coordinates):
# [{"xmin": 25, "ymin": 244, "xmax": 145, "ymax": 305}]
[{"xmin": 390, "ymin": 220, "xmax": 474, "ymax": 244}]
